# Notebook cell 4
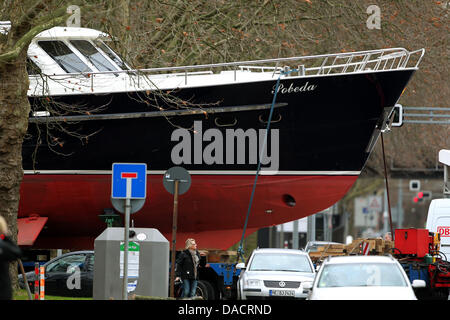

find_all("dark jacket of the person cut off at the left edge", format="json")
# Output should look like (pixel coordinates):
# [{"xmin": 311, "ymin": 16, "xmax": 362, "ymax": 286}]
[{"xmin": 0, "ymin": 237, "xmax": 22, "ymax": 300}]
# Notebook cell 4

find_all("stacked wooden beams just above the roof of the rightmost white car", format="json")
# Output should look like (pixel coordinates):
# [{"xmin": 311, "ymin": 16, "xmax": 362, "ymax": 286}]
[{"xmin": 309, "ymin": 238, "xmax": 394, "ymax": 262}]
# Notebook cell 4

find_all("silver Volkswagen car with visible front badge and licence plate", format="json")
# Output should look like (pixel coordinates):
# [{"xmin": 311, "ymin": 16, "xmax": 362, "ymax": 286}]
[{"xmin": 236, "ymin": 249, "xmax": 315, "ymax": 300}]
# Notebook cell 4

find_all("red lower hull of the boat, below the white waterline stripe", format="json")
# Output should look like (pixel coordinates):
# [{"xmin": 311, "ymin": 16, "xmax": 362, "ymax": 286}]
[{"xmin": 19, "ymin": 174, "xmax": 358, "ymax": 250}]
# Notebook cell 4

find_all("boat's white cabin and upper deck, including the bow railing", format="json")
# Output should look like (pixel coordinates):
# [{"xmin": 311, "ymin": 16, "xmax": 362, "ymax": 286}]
[{"xmin": 28, "ymin": 27, "xmax": 424, "ymax": 96}]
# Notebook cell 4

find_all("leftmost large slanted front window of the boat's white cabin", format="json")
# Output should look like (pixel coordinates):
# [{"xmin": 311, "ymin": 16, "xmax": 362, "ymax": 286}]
[{"xmin": 38, "ymin": 41, "xmax": 92, "ymax": 73}]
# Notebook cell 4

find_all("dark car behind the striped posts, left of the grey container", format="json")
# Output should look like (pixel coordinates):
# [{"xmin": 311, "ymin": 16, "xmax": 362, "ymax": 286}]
[{"xmin": 19, "ymin": 251, "xmax": 94, "ymax": 297}]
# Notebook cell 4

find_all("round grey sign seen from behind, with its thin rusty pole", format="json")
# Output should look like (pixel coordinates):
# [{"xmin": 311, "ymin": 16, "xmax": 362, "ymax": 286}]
[{"xmin": 163, "ymin": 167, "xmax": 191, "ymax": 298}]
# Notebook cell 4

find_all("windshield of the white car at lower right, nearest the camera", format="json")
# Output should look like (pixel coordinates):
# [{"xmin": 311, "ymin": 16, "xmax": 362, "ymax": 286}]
[{"xmin": 317, "ymin": 263, "xmax": 407, "ymax": 288}]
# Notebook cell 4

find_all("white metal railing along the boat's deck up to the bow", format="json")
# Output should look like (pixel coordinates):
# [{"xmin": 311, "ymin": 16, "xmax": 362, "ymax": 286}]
[{"xmin": 29, "ymin": 48, "xmax": 425, "ymax": 94}]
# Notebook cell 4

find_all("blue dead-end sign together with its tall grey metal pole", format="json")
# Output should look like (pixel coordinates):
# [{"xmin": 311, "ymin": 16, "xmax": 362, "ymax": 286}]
[{"xmin": 111, "ymin": 163, "xmax": 147, "ymax": 300}]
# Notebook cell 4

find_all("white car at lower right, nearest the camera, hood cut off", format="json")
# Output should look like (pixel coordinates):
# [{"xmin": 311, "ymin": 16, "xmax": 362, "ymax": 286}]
[{"xmin": 308, "ymin": 256, "xmax": 426, "ymax": 300}]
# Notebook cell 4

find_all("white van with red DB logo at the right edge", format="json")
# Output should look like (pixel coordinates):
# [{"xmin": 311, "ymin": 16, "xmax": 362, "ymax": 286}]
[{"xmin": 426, "ymin": 198, "xmax": 450, "ymax": 261}]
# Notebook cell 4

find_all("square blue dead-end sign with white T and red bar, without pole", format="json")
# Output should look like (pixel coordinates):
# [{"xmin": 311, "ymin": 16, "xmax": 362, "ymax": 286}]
[{"xmin": 111, "ymin": 163, "xmax": 147, "ymax": 199}]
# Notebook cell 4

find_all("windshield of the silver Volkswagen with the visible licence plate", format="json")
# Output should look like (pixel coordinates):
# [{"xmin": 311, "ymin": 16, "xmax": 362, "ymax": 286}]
[{"xmin": 248, "ymin": 253, "xmax": 313, "ymax": 272}]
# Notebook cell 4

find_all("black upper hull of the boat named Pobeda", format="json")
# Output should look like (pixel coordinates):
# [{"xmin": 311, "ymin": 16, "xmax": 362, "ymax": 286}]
[{"xmin": 23, "ymin": 69, "xmax": 415, "ymax": 174}]
